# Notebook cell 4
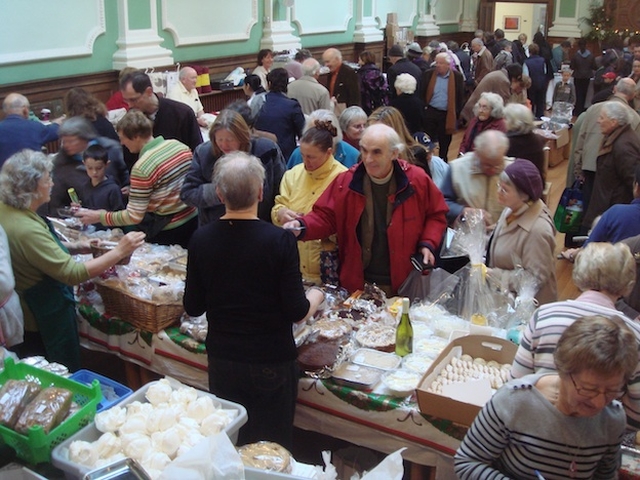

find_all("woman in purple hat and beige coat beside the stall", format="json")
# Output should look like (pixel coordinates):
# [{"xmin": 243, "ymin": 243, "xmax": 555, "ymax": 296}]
[{"xmin": 486, "ymin": 158, "xmax": 557, "ymax": 304}]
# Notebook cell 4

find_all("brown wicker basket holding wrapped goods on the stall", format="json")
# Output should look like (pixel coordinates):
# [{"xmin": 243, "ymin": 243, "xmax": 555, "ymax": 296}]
[{"xmin": 96, "ymin": 283, "xmax": 184, "ymax": 333}]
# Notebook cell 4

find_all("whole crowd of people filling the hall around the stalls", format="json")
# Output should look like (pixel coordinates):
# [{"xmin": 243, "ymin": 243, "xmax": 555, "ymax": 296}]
[{"xmin": 0, "ymin": 29, "xmax": 640, "ymax": 466}]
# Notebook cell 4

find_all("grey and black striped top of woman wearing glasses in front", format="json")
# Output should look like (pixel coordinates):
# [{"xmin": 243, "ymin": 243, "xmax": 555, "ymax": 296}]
[{"xmin": 454, "ymin": 375, "xmax": 625, "ymax": 480}]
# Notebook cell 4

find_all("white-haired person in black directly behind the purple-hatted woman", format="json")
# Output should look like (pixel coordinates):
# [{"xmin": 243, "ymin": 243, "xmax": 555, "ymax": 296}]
[{"xmin": 504, "ymin": 103, "xmax": 547, "ymax": 181}]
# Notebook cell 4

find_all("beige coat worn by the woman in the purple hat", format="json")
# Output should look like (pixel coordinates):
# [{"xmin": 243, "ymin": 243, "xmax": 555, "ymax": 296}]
[{"xmin": 487, "ymin": 200, "xmax": 558, "ymax": 305}]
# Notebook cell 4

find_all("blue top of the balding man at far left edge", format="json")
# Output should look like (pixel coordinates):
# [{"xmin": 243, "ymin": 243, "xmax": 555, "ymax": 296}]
[{"xmin": 0, "ymin": 114, "xmax": 59, "ymax": 167}]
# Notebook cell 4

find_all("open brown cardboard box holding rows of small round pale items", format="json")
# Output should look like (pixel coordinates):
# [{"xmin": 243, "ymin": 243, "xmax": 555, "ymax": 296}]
[{"xmin": 417, "ymin": 335, "xmax": 518, "ymax": 426}]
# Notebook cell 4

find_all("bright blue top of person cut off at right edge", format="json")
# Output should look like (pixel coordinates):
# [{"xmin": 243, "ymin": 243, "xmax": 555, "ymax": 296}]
[{"xmin": 584, "ymin": 198, "xmax": 640, "ymax": 245}]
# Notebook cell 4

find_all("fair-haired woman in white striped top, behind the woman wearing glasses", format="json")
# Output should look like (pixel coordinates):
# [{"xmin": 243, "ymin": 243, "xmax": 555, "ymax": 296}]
[{"xmin": 510, "ymin": 242, "xmax": 640, "ymax": 430}]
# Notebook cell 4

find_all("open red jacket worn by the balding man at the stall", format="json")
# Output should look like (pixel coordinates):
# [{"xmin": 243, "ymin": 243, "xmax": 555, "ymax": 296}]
[{"xmin": 300, "ymin": 160, "xmax": 448, "ymax": 292}]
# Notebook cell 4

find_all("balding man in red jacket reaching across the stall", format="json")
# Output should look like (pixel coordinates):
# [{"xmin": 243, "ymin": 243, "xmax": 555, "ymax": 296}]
[{"xmin": 284, "ymin": 124, "xmax": 448, "ymax": 295}]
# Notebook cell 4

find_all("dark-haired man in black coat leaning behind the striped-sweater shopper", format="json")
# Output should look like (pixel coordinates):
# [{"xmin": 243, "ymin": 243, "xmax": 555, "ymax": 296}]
[{"xmin": 120, "ymin": 71, "xmax": 203, "ymax": 170}]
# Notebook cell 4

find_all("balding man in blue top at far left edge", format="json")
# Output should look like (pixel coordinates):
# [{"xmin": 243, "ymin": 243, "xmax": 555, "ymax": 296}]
[{"xmin": 0, "ymin": 93, "xmax": 64, "ymax": 167}]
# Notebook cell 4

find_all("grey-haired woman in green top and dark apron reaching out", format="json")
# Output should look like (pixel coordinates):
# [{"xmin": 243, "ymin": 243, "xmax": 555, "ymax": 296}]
[{"xmin": 0, "ymin": 150, "xmax": 145, "ymax": 371}]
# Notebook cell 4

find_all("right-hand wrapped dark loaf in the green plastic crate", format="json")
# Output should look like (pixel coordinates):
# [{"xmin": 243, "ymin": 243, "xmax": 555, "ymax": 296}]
[{"xmin": 15, "ymin": 387, "xmax": 73, "ymax": 435}]
